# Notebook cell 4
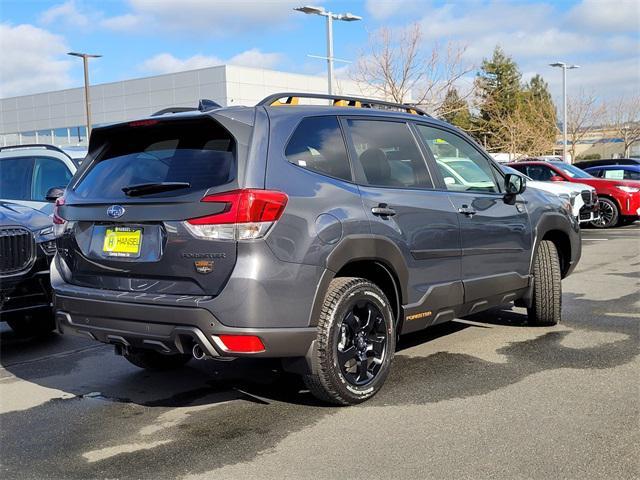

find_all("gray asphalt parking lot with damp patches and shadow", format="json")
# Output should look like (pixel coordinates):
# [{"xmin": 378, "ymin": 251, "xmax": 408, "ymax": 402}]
[{"xmin": 0, "ymin": 223, "xmax": 640, "ymax": 480}]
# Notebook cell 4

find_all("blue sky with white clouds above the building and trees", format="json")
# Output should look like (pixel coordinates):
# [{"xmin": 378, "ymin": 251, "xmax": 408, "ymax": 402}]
[{"xmin": 0, "ymin": 0, "xmax": 640, "ymax": 103}]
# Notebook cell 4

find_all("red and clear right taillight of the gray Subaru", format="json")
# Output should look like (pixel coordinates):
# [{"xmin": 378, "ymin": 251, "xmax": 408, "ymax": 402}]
[{"xmin": 184, "ymin": 189, "xmax": 288, "ymax": 240}]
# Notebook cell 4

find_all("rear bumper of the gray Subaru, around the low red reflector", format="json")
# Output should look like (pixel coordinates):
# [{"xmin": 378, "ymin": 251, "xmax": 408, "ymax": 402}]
[{"xmin": 55, "ymin": 294, "xmax": 316, "ymax": 358}]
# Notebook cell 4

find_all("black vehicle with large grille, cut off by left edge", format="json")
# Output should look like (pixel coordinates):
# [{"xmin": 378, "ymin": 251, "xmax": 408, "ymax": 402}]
[{"xmin": 0, "ymin": 202, "xmax": 56, "ymax": 336}]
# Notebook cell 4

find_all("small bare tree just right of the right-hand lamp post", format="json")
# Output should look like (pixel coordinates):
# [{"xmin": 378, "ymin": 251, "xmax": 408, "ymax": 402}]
[{"xmin": 567, "ymin": 90, "xmax": 606, "ymax": 161}]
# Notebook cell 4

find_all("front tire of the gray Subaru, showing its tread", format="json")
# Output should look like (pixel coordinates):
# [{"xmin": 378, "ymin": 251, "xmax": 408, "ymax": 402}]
[{"xmin": 527, "ymin": 240, "xmax": 562, "ymax": 325}]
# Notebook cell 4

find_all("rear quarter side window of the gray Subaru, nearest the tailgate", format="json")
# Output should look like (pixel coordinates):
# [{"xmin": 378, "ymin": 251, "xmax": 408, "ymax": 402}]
[{"xmin": 285, "ymin": 117, "xmax": 351, "ymax": 181}]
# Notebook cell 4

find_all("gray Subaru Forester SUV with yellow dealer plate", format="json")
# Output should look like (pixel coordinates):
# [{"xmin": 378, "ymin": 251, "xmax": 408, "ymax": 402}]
[{"xmin": 51, "ymin": 93, "xmax": 581, "ymax": 404}]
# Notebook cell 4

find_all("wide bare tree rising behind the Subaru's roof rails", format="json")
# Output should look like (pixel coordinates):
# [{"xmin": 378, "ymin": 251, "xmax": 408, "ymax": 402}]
[{"xmin": 351, "ymin": 23, "xmax": 473, "ymax": 114}]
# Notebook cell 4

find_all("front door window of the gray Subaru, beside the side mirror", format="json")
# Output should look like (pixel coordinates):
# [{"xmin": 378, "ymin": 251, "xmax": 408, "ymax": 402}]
[{"xmin": 418, "ymin": 125, "xmax": 500, "ymax": 192}]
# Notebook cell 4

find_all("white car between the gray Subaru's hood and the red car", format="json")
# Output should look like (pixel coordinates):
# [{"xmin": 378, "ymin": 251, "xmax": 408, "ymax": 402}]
[{"xmin": 501, "ymin": 165, "xmax": 600, "ymax": 223}]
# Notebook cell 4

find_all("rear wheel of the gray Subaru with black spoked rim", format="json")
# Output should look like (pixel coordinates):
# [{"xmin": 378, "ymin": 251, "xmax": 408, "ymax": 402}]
[{"xmin": 303, "ymin": 277, "xmax": 396, "ymax": 405}]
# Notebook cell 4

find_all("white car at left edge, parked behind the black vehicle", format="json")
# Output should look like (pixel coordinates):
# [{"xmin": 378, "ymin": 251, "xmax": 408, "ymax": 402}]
[{"xmin": 0, "ymin": 144, "xmax": 78, "ymax": 214}]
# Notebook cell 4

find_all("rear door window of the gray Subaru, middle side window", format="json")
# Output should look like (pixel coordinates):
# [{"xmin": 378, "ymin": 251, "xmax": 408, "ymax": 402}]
[{"xmin": 347, "ymin": 120, "xmax": 433, "ymax": 188}]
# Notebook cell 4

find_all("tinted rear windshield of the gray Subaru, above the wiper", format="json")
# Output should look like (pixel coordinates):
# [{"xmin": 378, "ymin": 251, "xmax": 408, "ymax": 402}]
[{"xmin": 74, "ymin": 119, "xmax": 237, "ymax": 200}]
